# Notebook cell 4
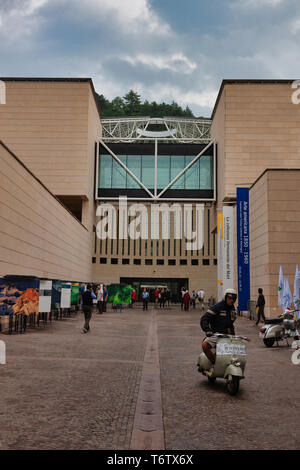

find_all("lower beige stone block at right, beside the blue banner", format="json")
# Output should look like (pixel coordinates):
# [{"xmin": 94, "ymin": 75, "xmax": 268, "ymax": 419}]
[{"xmin": 250, "ymin": 170, "xmax": 300, "ymax": 316}]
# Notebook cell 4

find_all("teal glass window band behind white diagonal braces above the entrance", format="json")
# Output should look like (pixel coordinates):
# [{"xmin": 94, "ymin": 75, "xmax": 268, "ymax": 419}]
[{"xmin": 98, "ymin": 154, "xmax": 213, "ymax": 190}]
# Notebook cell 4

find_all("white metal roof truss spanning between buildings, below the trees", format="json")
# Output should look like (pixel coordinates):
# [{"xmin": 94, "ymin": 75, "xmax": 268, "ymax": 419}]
[{"xmin": 101, "ymin": 116, "xmax": 211, "ymax": 143}]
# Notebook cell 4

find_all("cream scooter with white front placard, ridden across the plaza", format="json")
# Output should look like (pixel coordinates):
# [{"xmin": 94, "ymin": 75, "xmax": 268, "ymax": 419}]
[{"xmin": 197, "ymin": 333, "xmax": 250, "ymax": 395}]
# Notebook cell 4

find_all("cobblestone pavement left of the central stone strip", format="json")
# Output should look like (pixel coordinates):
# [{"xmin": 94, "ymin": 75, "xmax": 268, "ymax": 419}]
[{"xmin": 0, "ymin": 311, "xmax": 149, "ymax": 449}]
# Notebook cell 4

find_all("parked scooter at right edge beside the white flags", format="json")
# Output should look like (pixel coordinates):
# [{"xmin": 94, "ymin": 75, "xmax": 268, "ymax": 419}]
[{"xmin": 259, "ymin": 309, "xmax": 300, "ymax": 348}]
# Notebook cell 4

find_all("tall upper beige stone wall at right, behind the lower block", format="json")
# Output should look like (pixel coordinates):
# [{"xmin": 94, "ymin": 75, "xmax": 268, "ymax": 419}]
[{"xmin": 211, "ymin": 83, "xmax": 300, "ymax": 201}]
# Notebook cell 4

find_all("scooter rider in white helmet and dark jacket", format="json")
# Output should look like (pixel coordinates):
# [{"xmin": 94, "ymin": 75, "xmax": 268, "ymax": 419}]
[{"xmin": 200, "ymin": 289, "xmax": 237, "ymax": 364}]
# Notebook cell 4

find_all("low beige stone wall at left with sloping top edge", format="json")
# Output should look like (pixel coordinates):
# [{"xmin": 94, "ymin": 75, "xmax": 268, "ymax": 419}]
[{"xmin": 0, "ymin": 144, "xmax": 91, "ymax": 281}]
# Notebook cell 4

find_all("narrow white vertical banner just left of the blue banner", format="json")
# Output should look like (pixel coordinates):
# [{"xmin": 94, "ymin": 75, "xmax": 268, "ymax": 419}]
[{"xmin": 223, "ymin": 206, "xmax": 233, "ymax": 292}]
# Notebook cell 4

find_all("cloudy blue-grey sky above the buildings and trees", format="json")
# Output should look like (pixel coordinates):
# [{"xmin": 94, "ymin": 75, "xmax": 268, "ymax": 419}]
[{"xmin": 0, "ymin": 0, "xmax": 300, "ymax": 116}]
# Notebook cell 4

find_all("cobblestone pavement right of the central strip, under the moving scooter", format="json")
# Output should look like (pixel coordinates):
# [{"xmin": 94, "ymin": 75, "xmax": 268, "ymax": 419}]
[{"xmin": 158, "ymin": 310, "xmax": 300, "ymax": 450}]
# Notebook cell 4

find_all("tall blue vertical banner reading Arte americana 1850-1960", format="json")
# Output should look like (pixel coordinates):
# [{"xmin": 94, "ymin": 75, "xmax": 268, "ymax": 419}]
[{"xmin": 236, "ymin": 188, "xmax": 250, "ymax": 312}]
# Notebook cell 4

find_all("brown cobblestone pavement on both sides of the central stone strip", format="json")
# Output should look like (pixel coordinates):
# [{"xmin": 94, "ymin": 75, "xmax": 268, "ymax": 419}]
[{"xmin": 0, "ymin": 307, "xmax": 300, "ymax": 450}]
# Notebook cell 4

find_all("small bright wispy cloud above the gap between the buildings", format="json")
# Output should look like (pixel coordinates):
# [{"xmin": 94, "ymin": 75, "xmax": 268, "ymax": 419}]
[{"xmin": 122, "ymin": 52, "xmax": 197, "ymax": 74}]
